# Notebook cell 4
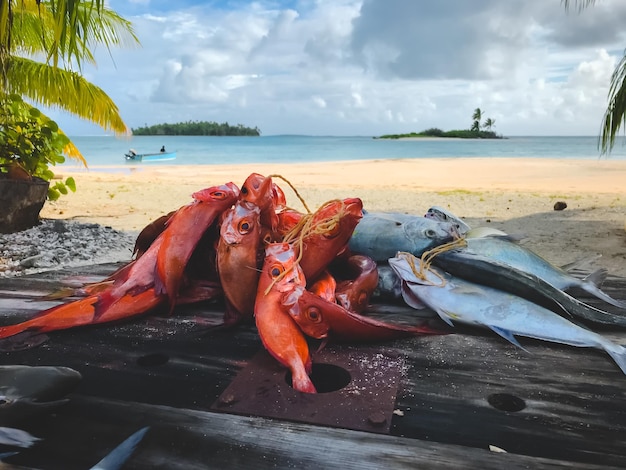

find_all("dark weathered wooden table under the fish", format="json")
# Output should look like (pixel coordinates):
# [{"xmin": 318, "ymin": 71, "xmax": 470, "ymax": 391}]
[{"xmin": 0, "ymin": 264, "xmax": 626, "ymax": 470}]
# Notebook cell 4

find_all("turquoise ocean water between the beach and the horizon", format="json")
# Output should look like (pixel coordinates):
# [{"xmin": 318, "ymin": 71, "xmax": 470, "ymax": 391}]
[{"xmin": 65, "ymin": 135, "xmax": 626, "ymax": 170}]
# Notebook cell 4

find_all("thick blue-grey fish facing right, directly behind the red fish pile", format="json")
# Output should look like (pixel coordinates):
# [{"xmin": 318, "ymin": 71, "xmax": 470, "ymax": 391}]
[{"xmin": 349, "ymin": 212, "xmax": 460, "ymax": 261}]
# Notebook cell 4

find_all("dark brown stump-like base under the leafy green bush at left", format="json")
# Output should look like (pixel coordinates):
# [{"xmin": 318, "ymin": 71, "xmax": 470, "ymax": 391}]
[{"xmin": 0, "ymin": 178, "xmax": 50, "ymax": 233}]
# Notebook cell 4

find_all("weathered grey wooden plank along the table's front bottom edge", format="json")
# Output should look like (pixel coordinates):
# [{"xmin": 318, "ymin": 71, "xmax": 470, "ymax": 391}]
[{"xmin": 15, "ymin": 396, "xmax": 618, "ymax": 470}]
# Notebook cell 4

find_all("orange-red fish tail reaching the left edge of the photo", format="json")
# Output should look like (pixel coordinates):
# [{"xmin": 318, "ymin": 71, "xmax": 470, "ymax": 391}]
[{"xmin": 0, "ymin": 295, "xmax": 100, "ymax": 338}]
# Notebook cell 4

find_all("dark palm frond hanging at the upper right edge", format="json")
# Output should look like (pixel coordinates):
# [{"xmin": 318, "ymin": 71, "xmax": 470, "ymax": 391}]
[{"xmin": 561, "ymin": 0, "xmax": 626, "ymax": 153}]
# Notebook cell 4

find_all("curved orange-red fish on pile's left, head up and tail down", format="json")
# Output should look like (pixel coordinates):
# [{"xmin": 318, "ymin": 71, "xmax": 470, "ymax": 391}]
[{"xmin": 155, "ymin": 183, "xmax": 239, "ymax": 311}]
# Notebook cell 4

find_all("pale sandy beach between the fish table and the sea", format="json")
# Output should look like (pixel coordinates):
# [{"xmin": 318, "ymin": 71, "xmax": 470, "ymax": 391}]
[{"xmin": 41, "ymin": 158, "xmax": 626, "ymax": 277}]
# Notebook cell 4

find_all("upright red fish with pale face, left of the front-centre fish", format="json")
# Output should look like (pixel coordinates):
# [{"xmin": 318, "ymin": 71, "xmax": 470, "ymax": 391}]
[{"xmin": 217, "ymin": 201, "xmax": 263, "ymax": 322}]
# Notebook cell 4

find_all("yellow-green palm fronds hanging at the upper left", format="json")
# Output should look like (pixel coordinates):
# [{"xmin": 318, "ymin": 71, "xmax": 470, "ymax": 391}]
[{"xmin": 0, "ymin": 0, "xmax": 139, "ymax": 162}]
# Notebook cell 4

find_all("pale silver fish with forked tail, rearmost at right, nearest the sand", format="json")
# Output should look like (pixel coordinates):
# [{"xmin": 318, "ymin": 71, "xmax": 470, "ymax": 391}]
[{"xmin": 458, "ymin": 237, "xmax": 626, "ymax": 308}]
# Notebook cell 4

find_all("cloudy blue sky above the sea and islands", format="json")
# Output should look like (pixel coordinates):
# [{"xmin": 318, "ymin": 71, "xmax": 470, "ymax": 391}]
[{"xmin": 49, "ymin": 0, "xmax": 626, "ymax": 136}]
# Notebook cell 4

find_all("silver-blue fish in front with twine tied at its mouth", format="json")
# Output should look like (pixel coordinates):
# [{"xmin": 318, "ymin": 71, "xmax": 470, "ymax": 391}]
[{"xmin": 389, "ymin": 254, "xmax": 626, "ymax": 374}]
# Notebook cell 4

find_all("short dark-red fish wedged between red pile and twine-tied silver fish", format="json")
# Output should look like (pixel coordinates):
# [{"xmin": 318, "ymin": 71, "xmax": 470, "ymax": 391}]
[{"xmin": 335, "ymin": 255, "xmax": 378, "ymax": 313}]
